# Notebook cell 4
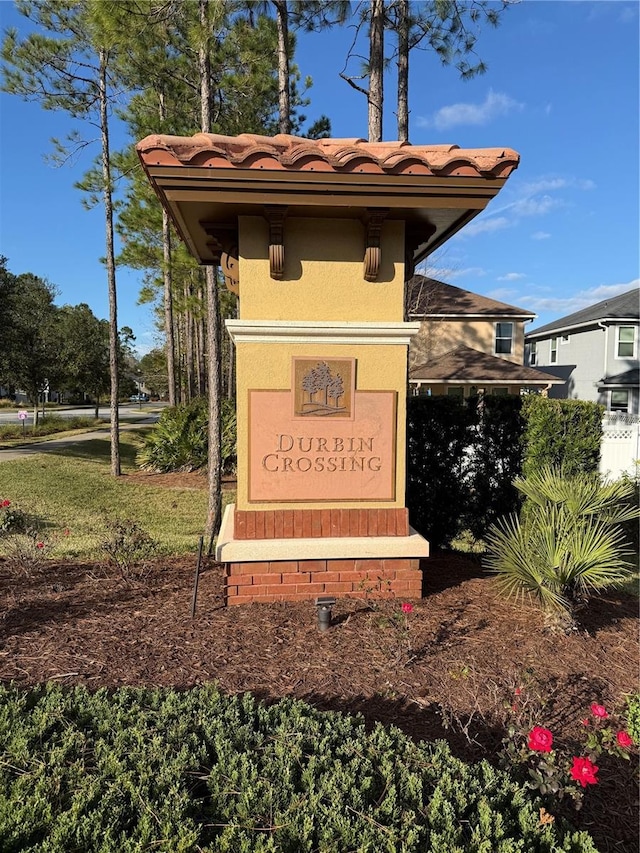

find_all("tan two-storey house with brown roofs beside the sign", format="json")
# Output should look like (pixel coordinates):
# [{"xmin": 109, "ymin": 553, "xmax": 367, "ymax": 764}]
[{"xmin": 406, "ymin": 275, "xmax": 562, "ymax": 397}]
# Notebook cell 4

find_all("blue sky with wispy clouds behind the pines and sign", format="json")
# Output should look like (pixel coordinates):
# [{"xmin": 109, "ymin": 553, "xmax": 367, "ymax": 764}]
[{"xmin": 0, "ymin": 0, "xmax": 640, "ymax": 351}]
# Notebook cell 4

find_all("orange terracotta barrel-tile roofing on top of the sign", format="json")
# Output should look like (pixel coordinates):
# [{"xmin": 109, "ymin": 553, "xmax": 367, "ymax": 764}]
[{"xmin": 136, "ymin": 133, "xmax": 520, "ymax": 178}]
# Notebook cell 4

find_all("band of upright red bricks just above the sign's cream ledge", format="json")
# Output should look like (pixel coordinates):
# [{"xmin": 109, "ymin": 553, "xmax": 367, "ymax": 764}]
[{"xmin": 234, "ymin": 507, "xmax": 409, "ymax": 539}]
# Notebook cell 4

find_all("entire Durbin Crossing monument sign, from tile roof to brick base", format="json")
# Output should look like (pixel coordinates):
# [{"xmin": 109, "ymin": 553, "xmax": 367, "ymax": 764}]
[{"xmin": 137, "ymin": 134, "xmax": 518, "ymax": 604}]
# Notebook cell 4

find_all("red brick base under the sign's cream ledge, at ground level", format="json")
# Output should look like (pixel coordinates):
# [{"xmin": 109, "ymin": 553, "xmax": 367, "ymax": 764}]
[{"xmin": 225, "ymin": 559, "xmax": 422, "ymax": 604}]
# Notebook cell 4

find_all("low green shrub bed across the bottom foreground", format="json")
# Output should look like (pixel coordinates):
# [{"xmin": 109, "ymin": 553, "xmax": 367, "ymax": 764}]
[{"xmin": 0, "ymin": 686, "xmax": 595, "ymax": 853}]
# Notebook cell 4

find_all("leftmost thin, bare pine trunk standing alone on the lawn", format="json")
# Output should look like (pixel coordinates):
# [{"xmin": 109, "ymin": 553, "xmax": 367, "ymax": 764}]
[{"xmin": 98, "ymin": 48, "xmax": 121, "ymax": 477}]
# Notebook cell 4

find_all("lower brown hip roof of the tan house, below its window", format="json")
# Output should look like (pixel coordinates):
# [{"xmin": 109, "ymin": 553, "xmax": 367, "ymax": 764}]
[{"xmin": 409, "ymin": 346, "xmax": 564, "ymax": 385}]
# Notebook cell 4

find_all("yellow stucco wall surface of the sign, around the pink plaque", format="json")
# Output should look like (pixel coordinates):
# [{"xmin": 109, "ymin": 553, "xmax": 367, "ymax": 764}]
[{"xmin": 236, "ymin": 217, "xmax": 407, "ymax": 510}]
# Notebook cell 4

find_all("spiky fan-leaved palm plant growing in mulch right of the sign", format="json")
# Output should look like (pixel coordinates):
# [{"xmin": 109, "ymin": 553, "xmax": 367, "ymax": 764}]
[{"xmin": 486, "ymin": 466, "xmax": 640, "ymax": 627}]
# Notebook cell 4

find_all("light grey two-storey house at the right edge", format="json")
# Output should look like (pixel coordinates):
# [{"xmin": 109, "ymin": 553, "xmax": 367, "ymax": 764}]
[{"xmin": 526, "ymin": 287, "xmax": 640, "ymax": 415}]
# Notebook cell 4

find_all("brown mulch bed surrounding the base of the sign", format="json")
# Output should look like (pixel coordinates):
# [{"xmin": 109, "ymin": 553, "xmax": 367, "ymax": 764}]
[{"xmin": 0, "ymin": 548, "xmax": 638, "ymax": 853}]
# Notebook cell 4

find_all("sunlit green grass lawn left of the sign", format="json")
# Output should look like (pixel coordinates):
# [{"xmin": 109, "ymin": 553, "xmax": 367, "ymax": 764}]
[{"xmin": 0, "ymin": 431, "xmax": 228, "ymax": 558}]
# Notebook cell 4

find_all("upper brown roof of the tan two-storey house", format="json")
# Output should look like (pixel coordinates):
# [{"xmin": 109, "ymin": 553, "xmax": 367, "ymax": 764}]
[{"xmin": 407, "ymin": 275, "xmax": 536, "ymax": 318}]
